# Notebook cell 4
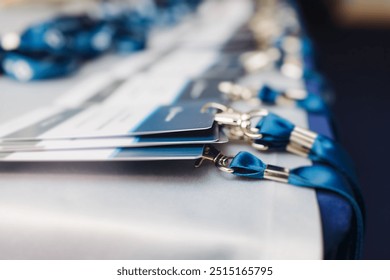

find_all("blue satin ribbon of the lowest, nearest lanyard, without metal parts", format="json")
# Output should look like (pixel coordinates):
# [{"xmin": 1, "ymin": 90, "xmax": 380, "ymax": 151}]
[{"xmin": 229, "ymin": 152, "xmax": 365, "ymax": 259}]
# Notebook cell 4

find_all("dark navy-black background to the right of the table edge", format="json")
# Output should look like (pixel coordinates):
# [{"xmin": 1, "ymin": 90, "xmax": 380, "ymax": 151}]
[{"xmin": 297, "ymin": 0, "xmax": 390, "ymax": 259}]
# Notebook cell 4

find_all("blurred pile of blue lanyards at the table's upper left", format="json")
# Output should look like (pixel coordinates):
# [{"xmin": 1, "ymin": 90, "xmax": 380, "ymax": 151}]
[{"xmin": 0, "ymin": 0, "xmax": 201, "ymax": 81}]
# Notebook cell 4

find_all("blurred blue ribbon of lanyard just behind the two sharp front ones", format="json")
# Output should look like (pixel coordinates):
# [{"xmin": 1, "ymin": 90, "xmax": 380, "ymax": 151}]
[{"xmin": 257, "ymin": 85, "xmax": 328, "ymax": 113}]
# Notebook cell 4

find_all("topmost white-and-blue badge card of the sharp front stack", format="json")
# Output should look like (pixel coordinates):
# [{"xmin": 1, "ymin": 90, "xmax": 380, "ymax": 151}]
[{"xmin": 0, "ymin": 102, "xmax": 214, "ymax": 142}]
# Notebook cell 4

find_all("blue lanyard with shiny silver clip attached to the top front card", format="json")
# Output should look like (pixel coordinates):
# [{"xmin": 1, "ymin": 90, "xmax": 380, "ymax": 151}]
[{"xmin": 202, "ymin": 103, "xmax": 364, "ymax": 214}]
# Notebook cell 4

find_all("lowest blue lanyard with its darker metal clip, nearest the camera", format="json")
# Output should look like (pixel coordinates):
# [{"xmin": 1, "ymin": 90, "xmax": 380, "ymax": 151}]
[{"xmin": 195, "ymin": 146, "xmax": 365, "ymax": 259}]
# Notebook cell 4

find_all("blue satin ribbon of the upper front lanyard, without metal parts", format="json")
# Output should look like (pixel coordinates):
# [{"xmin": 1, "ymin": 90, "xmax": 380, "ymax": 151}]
[{"xmin": 255, "ymin": 113, "xmax": 364, "ymax": 213}]
